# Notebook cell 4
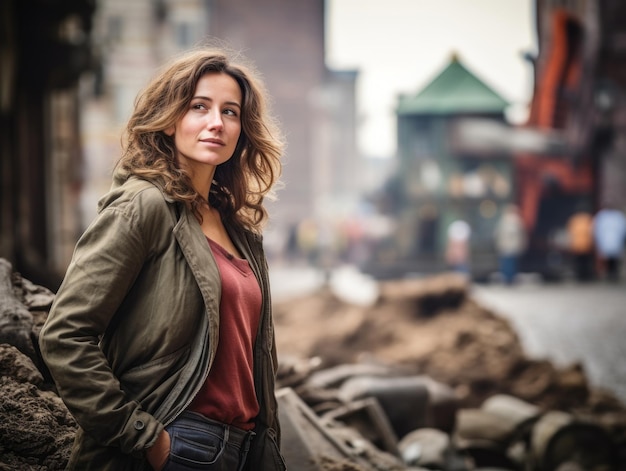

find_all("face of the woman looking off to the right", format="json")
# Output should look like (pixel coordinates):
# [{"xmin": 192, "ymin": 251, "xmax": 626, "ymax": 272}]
[{"xmin": 166, "ymin": 72, "xmax": 242, "ymax": 175}]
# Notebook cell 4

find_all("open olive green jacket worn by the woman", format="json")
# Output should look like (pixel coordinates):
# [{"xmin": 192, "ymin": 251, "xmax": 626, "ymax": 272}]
[{"xmin": 39, "ymin": 174, "xmax": 279, "ymax": 471}]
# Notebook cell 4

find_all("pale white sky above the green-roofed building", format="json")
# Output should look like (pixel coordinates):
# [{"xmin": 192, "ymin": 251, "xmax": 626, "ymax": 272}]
[{"xmin": 327, "ymin": 0, "xmax": 536, "ymax": 157}]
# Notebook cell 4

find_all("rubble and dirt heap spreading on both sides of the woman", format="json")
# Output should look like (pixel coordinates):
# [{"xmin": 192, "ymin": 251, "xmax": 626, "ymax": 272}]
[{"xmin": 0, "ymin": 259, "xmax": 626, "ymax": 471}]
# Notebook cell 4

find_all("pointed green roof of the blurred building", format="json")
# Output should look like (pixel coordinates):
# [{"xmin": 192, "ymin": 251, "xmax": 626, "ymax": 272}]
[{"xmin": 396, "ymin": 55, "xmax": 509, "ymax": 116}]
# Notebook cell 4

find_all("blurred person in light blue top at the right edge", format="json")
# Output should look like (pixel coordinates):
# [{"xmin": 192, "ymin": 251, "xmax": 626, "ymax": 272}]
[{"xmin": 593, "ymin": 203, "xmax": 626, "ymax": 281}]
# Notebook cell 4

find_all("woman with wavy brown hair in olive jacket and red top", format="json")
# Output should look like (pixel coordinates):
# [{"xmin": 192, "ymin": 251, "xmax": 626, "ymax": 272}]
[{"xmin": 40, "ymin": 46, "xmax": 284, "ymax": 471}]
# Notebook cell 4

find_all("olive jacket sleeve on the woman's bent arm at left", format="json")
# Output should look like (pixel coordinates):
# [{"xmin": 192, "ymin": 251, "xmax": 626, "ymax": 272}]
[{"xmin": 39, "ymin": 201, "xmax": 163, "ymax": 453}]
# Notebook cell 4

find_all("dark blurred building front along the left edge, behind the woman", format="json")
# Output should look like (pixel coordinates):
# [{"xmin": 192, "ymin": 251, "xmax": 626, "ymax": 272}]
[{"xmin": 0, "ymin": 0, "xmax": 95, "ymax": 286}]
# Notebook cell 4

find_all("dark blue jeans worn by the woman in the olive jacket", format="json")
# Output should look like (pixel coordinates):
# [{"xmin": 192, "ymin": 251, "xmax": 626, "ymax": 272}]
[{"xmin": 163, "ymin": 411, "xmax": 254, "ymax": 471}]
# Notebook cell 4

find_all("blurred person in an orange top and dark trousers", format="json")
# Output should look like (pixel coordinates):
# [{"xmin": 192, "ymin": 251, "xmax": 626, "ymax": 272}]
[{"xmin": 567, "ymin": 207, "xmax": 594, "ymax": 282}]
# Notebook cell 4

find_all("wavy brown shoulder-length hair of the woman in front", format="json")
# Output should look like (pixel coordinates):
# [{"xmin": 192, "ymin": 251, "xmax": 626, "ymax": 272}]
[{"xmin": 117, "ymin": 48, "xmax": 284, "ymax": 231}]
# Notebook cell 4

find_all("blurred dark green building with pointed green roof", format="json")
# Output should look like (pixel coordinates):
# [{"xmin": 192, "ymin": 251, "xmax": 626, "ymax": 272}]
[{"xmin": 367, "ymin": 55, "xmax": 514, "ymax": 276}]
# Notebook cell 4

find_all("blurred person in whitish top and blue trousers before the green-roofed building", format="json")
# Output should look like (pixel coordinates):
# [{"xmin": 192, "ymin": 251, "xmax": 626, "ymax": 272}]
[{"xmin": 495, "ymin": 204, "xmax": 527, "ymax": 285}]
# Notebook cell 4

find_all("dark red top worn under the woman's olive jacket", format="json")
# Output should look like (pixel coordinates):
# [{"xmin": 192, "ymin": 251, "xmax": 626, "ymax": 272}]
[{"xmin": 189, "ymin": 239, "xmax": 262, "ymax": 430}]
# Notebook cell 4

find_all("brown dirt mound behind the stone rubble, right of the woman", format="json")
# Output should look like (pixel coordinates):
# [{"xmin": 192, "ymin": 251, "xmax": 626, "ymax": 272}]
[{"xmin": 274, "ymin": 274, "xmax": 613, "ymax": 409}]
